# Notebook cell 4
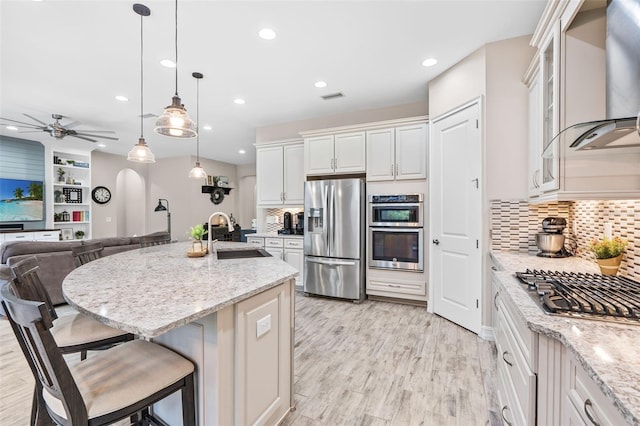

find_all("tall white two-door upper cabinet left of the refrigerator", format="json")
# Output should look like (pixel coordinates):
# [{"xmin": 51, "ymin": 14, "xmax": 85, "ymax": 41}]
[{"xmin": 256, "ymin": 141, "xmax": 304, "ymax": 206}]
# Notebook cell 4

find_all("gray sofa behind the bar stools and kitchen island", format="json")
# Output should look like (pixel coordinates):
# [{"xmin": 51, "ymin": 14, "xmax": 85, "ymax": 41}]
[{"xmin": 0, "ymin": 232, "xmax": 167, "ymax": 305}]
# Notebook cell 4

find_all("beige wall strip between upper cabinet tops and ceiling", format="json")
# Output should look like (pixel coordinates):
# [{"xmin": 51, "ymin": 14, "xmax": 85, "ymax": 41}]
[{"xmin": 256, "ymin": 101, "xmax": 429, "ymax": 143}]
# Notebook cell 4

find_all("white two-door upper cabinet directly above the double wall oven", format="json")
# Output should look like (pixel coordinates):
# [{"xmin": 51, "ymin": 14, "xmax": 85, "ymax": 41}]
[{"xmin": 367, "ymin": 124, "xmax": 427, "ymax": 181}]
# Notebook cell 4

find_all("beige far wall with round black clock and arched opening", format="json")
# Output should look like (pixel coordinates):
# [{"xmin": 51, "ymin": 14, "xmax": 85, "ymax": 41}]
[{"xmin": 91, "ymin": 151, "xmax": 241, "ymax": 241}]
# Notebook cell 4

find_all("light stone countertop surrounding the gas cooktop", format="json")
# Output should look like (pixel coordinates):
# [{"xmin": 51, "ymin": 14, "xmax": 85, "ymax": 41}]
[{"xmin": 491, "ymin": 251, "xmax": 640, "ymax": 425}]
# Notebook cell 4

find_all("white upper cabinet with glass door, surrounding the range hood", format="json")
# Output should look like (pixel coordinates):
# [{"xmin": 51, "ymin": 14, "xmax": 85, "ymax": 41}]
[{"xmin": 524, "ymin": 1, "xmax": 640, "ymax": 202}]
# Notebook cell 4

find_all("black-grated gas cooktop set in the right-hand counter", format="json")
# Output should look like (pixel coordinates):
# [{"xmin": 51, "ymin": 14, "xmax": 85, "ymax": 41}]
[{"xmin": 516, "ymin": 269, "xmax": 640, "ymax": 325}]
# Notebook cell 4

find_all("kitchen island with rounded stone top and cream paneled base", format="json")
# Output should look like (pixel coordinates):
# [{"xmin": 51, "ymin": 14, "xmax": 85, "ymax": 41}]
[{"xmin": 62, "ymin": 242, "xmax": 297, "ymax": 425}]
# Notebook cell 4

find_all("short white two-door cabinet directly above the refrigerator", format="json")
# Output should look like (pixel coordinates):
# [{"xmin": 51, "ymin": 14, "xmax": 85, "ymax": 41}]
[{"xmin": 304, "ymin": 132, "xmax": 366, "ymax": 176}]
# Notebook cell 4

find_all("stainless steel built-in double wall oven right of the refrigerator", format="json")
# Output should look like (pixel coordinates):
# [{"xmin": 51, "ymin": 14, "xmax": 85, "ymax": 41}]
[{"xmin": 368, "ymin": 194, "xmax": 424, "ymax": 272}]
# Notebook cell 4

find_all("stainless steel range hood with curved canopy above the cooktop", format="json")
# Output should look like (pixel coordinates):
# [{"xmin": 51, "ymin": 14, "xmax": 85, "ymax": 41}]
[{"xmin": 550, "ymin": 0, "xmax": 640, "ymax": 150}]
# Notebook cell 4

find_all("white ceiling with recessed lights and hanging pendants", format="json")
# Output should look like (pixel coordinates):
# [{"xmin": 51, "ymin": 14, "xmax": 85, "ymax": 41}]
[{"xmin": 0, "ymin": 0, "xmax": 545, "ymax": 164}]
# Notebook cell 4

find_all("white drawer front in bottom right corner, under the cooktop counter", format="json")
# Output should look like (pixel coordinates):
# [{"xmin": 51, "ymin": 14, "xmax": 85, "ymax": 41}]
[{"xmin": 562, "ymin": 354, "xmax": 626, "ymax": 426}]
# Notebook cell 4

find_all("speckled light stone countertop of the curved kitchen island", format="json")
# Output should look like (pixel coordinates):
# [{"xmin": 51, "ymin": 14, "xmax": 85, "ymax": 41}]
[{"xmin": 62, "ymin": 242, "xmax": 298, "ymax": 338}]
